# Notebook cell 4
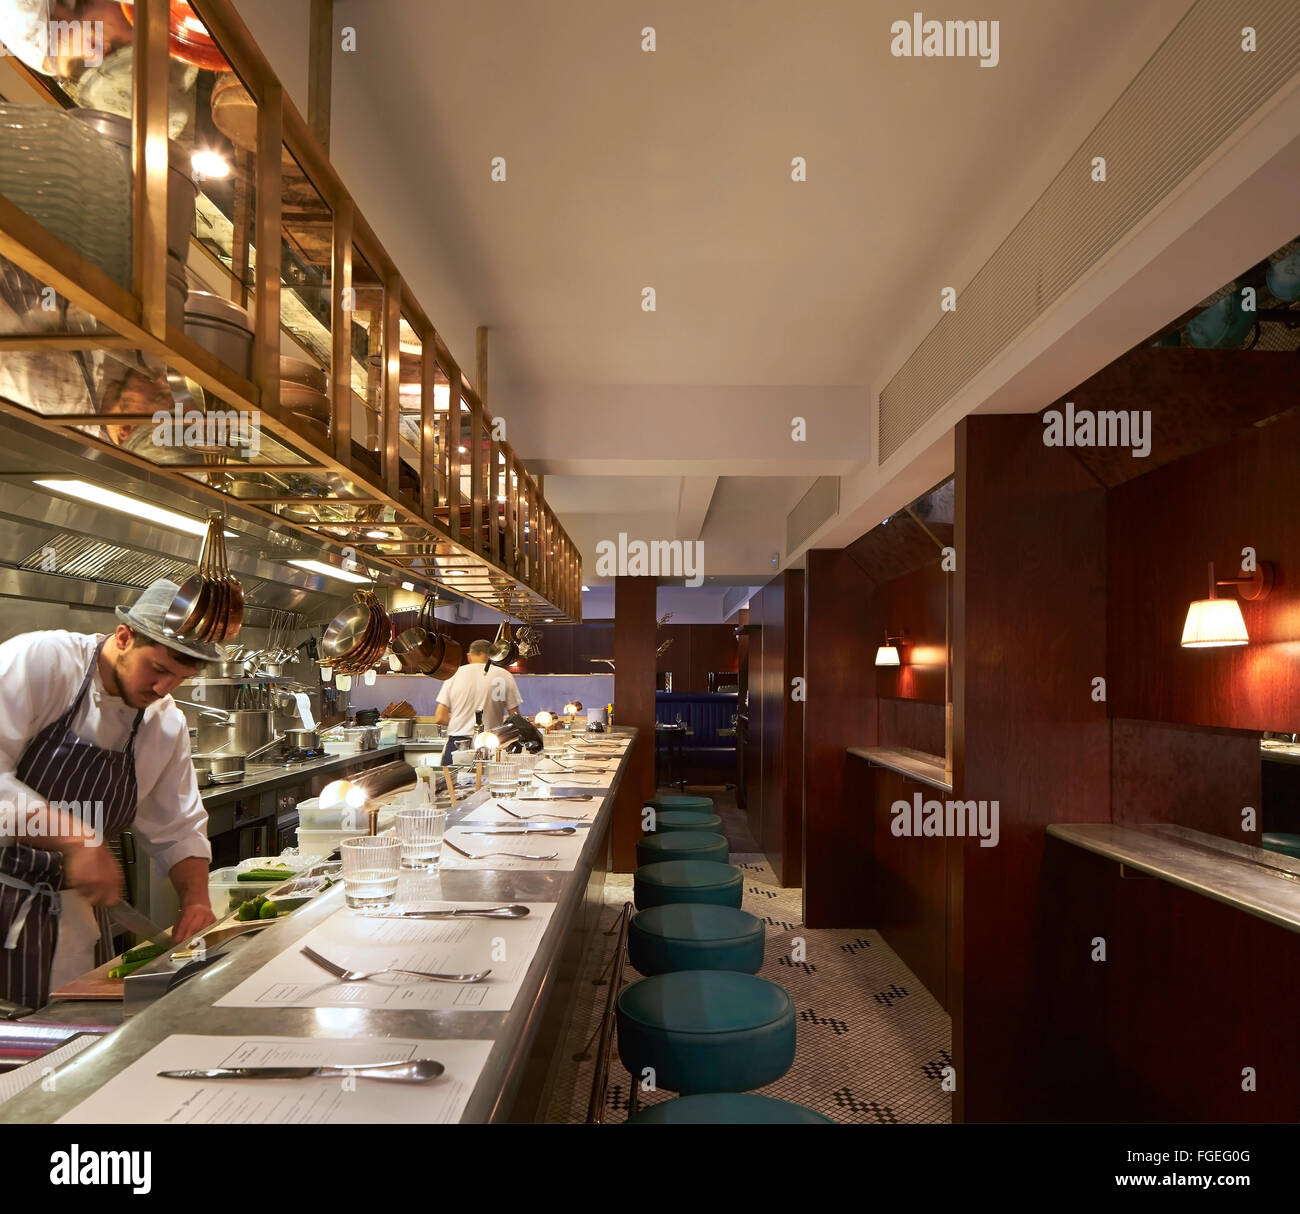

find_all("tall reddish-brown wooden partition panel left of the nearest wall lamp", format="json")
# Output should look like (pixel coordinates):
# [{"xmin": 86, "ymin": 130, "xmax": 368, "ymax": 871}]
[{"xmin": 949, "ymin": 415, "xmax": 1110, "ymax": 1122}]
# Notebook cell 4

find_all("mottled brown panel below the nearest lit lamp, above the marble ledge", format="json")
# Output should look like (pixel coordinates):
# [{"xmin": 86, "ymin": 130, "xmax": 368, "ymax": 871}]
[{"xmin": 1110, "ymin": 720, "xmax": 1261, "ymax": 846}]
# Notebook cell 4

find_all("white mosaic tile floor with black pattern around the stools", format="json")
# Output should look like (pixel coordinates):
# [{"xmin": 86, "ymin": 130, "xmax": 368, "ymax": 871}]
[{"xmin": 545, "ymin": 790, "xmax": 952, "ymax": 1124}]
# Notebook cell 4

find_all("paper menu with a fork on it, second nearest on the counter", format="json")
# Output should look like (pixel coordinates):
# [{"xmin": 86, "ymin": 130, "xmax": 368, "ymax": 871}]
[{"xmin": 215, "ymin": 902, "xmax": 555, "ymax": 1011}]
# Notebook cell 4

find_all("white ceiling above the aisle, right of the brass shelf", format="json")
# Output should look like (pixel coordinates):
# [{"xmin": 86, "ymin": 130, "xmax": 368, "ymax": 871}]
[{"xmin": 241, "ymin": 0, "xmax": 1227, "ymax": 584}]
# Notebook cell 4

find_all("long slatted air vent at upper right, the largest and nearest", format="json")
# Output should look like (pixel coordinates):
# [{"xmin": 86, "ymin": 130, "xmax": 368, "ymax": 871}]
[{"xmin": 878, "ymin": 0, "xmax": 1300, "ymax": 463}]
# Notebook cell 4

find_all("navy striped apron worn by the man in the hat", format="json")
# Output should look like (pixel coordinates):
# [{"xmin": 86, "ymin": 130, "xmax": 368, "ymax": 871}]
[{"xmin": 0, "ymin": 645, "xmax": 144, "ymax": 1007}]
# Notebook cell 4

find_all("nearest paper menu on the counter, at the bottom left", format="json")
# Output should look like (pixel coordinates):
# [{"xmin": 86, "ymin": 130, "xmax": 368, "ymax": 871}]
[{"xmin": 59, "ymin": 1033, "xmax": 493, "ymax": 1128}]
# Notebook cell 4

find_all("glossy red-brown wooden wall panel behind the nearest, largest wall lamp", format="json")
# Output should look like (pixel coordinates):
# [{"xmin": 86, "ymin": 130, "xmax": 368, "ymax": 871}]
[{"xmin": 1106, "ymin": 405, "xmax": 1300, "ymax": 732}]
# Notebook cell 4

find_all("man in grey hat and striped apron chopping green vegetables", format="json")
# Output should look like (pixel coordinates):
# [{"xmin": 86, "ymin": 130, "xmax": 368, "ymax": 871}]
[{"xmin": 0, "ymin": 580, "xmax": 220, "ymax": 1007}]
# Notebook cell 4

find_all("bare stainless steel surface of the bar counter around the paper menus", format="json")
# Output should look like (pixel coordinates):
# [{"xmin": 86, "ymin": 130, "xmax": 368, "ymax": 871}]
[{"xmin": 0, "ymin": 729, "xmax": 636, "ymax": 1122}]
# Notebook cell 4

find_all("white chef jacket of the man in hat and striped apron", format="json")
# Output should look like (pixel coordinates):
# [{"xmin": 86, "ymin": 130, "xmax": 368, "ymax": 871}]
[{"xmin": 0, "ymin": 632, "xmax": 212, "ymax": 988}]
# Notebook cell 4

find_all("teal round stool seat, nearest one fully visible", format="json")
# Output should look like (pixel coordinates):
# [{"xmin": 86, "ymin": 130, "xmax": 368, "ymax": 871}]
[{"xmin": 618, "ymin": 970, "xmax": 794, "ymax": 1096}]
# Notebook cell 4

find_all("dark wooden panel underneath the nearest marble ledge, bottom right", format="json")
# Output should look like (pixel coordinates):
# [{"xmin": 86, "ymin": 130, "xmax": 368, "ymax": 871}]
[{"xmin": 1036, "ymin": 840, "xmax": 1300, "ymax": 1123}]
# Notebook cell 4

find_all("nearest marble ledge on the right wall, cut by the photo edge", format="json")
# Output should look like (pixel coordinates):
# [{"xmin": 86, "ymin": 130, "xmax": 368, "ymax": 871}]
[{"xmin": 1048, "ymin": 823, "xmax": 1300, "ymax": 932}]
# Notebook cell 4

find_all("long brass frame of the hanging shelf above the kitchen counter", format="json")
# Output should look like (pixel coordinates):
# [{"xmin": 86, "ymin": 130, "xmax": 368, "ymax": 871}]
[{"xmin": 0, "ymin": 0, "xmax": 582, "ymax": 623}]
